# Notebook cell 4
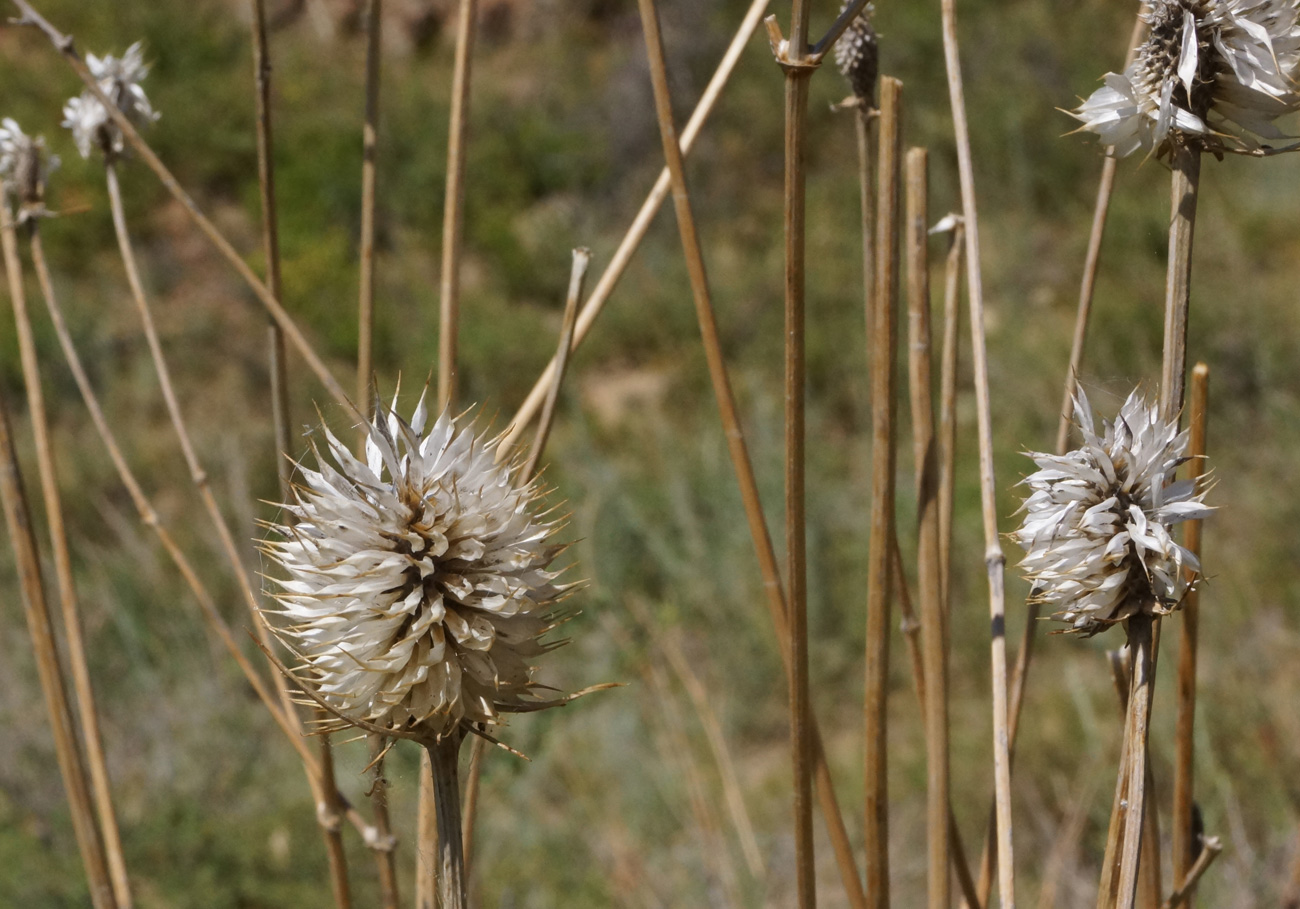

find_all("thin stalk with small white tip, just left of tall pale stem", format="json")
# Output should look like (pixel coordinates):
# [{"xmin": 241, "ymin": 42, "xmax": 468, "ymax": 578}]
[{"xmin": 939, "ymin": 221, "xmax": 961, "ymax": 608}]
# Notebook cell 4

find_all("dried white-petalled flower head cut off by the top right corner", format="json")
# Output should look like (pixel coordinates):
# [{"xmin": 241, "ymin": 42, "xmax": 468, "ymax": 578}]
[{"xmin": 1071, "ymin": 0, "xmax": 1300, "ymax": 157}]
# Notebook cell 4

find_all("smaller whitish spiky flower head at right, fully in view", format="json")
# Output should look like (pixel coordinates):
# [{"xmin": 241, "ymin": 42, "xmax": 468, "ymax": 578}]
[{"xmin": 1013, "ymin": 390, "xmax": 1212, "ymax": 635}]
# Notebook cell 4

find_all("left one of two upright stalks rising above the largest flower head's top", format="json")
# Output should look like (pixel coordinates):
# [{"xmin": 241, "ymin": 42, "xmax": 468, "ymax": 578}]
[{"xmin": 356, "ymin": 0, "xmax": 384, "ymax": 418}]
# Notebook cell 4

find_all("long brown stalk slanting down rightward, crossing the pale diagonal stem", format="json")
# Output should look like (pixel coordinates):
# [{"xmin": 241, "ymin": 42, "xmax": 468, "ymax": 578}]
[{"xmin": 639, "ymin": 0, "xmax": 863, "ymax": 906}]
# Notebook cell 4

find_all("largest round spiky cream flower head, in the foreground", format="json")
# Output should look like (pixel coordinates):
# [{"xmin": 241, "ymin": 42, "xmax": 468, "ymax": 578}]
[{"xmin": 264, "ymin": 398, "xmax": 567, "ymax": 739}]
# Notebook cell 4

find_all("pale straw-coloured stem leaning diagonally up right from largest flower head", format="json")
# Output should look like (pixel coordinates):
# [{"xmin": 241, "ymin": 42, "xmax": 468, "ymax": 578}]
[{"xmin": 498, "ymin": 0, "xmax": 771, "ymax": 454}]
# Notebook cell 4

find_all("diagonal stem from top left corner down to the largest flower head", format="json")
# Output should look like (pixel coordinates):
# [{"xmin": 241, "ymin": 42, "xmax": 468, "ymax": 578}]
[{"xmin": 13, "ymin": 0, "xmax": 363, "ymax": 419}]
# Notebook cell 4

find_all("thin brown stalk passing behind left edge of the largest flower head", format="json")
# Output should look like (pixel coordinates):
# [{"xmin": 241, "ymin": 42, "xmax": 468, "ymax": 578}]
[{"xmin": 250, "ymin": 0, "xmax": 352, "ymax": 909}]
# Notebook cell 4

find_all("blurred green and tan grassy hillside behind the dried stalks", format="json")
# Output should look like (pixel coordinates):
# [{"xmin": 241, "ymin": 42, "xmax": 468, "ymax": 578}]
[{"xmin": 0, "ymin": 0, "xmax": 1300, "ymax": 908}]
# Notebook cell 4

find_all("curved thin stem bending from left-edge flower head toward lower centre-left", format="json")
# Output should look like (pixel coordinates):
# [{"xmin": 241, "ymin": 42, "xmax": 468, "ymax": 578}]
[{"xmin": 31, "ymin": 225, "xmax": 369, "ymax": 835}]
